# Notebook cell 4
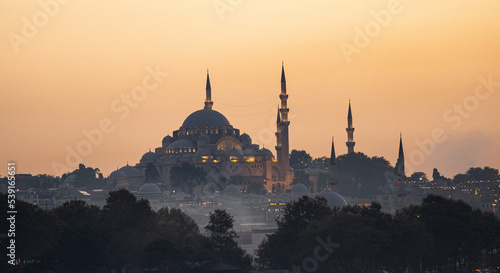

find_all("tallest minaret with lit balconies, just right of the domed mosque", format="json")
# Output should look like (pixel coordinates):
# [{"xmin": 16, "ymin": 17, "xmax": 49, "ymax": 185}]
[{"xmin": 276, "ymin": 63, "xmax": 290, "ymax": 172}]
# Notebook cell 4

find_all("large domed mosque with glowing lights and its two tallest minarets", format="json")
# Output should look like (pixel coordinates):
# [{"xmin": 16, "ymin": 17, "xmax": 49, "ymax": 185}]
[{"xmin": 109, "ymin": 65, "xmax": 293, "ymax": 194}]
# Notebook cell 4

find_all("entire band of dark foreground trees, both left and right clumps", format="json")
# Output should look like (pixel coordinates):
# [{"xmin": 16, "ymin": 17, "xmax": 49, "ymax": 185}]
[{"xmin": 0, "ymin": 190, "xmax": 500, "ymax": 273}]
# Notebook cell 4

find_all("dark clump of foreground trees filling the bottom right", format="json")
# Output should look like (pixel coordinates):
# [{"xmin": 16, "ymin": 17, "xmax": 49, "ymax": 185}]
[{"xmin": 257, "ymin": 195, "xmax": 500, "ymax": 273}]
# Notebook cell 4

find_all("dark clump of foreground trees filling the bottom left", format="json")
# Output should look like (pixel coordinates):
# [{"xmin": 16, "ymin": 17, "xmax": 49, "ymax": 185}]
[{"xmin": 0, "ymin": 190, "xmax": 251, "ymax": 273}]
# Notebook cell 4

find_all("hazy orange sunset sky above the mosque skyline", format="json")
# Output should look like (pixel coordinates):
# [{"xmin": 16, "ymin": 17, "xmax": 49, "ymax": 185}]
[{"xmin": 0, "ymin": 0, "xmax": 500, "ymax": 176}]
